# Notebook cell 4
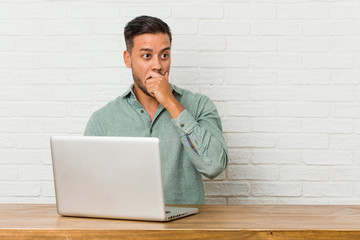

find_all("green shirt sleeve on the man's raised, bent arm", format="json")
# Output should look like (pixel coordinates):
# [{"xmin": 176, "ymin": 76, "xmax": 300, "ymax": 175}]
[{"xmin": 172, "ymin": 98, "xmax": 228, "ymax": 179}]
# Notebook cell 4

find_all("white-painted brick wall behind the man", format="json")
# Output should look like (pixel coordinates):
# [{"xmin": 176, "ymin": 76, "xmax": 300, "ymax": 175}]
[{"xmin": 0, "ymin": 0, "xmax": 360, "ymax": 204}]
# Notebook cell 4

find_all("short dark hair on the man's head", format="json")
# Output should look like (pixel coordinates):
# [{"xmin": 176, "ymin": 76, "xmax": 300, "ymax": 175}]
[{"xmin": 124, "ymin": 16, "xmax": 172, "ymax": 52}]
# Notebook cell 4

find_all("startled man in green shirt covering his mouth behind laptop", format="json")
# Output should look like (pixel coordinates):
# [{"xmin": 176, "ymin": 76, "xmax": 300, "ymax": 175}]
[{"xmin": 85, "ymin": 16, "xmax": 227, "ymax": 204}]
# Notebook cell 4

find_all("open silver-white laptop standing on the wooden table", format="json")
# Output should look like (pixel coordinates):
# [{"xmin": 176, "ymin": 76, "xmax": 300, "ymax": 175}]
[{"xmin": 50, "ymin": 136, "xmax": 198, "ymax": 221}]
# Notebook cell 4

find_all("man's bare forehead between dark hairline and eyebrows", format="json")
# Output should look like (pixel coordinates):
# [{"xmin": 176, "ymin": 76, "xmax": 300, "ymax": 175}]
[{"xmin": 133, "ymin": 33, "xmax": 170, "ymax": 50}]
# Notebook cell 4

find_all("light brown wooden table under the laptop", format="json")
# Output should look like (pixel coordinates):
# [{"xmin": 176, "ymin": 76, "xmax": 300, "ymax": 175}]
[{"xmin": 0, "ymin": 204, "xmax": 360, "ymax": 240}]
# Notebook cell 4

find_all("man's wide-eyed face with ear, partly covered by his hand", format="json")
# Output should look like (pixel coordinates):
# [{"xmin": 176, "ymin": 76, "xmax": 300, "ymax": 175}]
[{"xmin": 124, "ymin": 33, "xmax": 171, "ymax": 96}]
